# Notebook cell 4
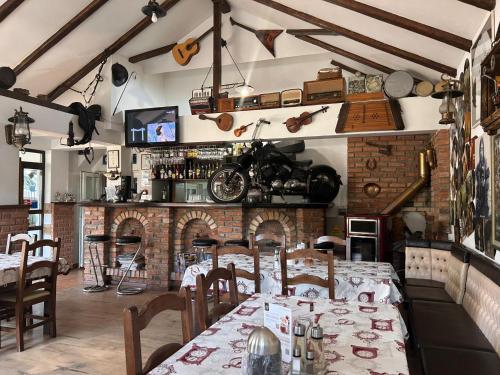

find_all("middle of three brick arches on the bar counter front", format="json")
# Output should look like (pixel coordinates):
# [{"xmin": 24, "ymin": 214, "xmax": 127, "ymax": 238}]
[{"xmin": 174, "ymin": 211, "xmax": 218, "ymax": 253}]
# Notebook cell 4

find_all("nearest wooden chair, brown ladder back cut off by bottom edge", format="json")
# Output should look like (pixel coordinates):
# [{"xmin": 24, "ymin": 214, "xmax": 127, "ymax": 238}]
[{"xmin": 123, "ymin": 287, "xmax": 193, "ymax": 375}]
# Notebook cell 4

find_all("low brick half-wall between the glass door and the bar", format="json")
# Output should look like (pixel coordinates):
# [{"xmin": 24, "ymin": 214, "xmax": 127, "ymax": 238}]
[{"xmin": 50, "ymin": 202, "xmax": 77, "ymax": 265}]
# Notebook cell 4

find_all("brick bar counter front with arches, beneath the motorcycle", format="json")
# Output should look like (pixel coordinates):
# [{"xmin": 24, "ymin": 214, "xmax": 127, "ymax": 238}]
[{"xmin": 78, "ymin": 201, "xmax": 328, "ymax": 288}]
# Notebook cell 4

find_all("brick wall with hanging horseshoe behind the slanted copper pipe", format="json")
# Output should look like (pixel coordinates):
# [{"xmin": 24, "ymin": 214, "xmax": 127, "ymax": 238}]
[{"xmin": 347, "ymin": 130, "xmax": 450, "ymax": 240}]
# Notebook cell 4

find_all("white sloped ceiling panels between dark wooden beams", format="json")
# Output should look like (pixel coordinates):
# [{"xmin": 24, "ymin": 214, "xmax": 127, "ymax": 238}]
[{"xmin": 0, "ymin": 0, "xmax": 487, "ymax": 95}]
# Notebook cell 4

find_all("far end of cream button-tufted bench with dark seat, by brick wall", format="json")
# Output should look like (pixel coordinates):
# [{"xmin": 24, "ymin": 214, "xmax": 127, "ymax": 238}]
[{"xmin": 405, "ymin": 242, "xmax": 470, "ymax": 303}]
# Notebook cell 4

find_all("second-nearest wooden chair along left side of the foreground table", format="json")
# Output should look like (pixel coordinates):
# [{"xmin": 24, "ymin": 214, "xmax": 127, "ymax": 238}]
[{"xmin": 196, "ymin": 263, "xmax": 238, "ymax": 332}]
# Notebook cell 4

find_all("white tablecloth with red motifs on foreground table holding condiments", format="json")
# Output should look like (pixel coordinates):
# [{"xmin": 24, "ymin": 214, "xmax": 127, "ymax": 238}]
[{"xmin": 149, "ymin": 294, "xmax": 408, "ymax": 375}]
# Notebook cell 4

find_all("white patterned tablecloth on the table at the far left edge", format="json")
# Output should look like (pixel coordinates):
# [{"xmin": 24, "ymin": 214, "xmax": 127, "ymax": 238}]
[{"xmin": 0, "ymin": 253, "xmax": 70, "ymax": 286}]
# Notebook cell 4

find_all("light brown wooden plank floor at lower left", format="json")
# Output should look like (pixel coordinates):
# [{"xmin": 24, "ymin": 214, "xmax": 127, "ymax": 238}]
[{"xmin": 0, "ymin": 271, "xmax": 182, "ymax": 375}]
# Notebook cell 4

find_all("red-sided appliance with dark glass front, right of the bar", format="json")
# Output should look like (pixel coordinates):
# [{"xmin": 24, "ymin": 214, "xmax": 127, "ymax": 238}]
[{"xmin": 346, "ymin": 215, "xmax": 392, "ymax": 262}]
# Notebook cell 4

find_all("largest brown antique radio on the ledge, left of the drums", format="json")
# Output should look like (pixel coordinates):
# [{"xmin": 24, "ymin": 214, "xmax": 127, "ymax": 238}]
[{"xmin": 303, "ymin": 78, "xmax": 345, "ymax": 104}]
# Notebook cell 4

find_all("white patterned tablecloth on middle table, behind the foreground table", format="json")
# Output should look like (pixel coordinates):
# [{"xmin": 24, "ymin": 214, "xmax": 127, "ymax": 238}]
[{"xmin": 182, "ymin": 254, "xmax": 403, "ymax": 304}]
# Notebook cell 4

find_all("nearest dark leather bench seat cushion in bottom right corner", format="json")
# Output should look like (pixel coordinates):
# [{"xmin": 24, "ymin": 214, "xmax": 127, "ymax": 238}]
[{"xmin": 421, "ymin": 347, "xmax": 500, "ymax": 375}]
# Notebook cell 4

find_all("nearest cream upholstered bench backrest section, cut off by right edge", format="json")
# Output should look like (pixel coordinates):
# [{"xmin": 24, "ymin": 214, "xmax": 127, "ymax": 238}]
[{"xmin": 462, "ymin": 254, "xmax": 500, "ymax": 356}]
